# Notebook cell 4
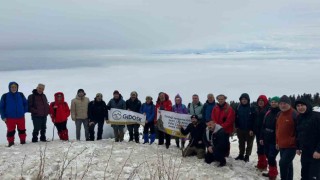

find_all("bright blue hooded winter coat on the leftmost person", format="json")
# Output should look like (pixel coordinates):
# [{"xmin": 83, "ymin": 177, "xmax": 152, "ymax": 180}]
[{"xmin": 0, "ymin": 82, "xmax": 28, "ymax": 119}]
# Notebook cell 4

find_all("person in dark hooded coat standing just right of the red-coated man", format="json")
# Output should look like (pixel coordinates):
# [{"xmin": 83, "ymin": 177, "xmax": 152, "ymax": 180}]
[{"xmin": 235, "ymin": 93, "xmax": 256, "ymax": 162}]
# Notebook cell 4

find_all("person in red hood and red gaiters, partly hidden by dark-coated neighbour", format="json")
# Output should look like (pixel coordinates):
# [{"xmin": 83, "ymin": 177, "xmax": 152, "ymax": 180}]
[{"xmin": 254, "ymin": 95, "xmax": 270, "ymax": 171}]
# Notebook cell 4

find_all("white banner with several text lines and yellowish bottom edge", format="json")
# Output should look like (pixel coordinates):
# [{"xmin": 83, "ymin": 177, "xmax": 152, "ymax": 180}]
[{"xmin": 157, "ymin": 110, "xmax": 191, "ymax": 137}]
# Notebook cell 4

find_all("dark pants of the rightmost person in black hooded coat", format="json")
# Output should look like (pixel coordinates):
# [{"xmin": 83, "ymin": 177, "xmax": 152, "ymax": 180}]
[{"xmin": 301, "ymin": 151, "xmax": 320, "ymax": 180}]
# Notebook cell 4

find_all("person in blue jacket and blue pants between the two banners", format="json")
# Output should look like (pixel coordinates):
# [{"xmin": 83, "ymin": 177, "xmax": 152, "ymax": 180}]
[{"xmin": 140, "ymin": 96, "xmax": 156, "ymax": 144}]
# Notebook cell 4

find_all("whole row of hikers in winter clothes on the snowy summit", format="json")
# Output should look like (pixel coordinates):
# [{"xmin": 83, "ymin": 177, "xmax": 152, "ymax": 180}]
[{"xmin": 0, "ymin": 82, "xmax": 320, "ymax": 180}]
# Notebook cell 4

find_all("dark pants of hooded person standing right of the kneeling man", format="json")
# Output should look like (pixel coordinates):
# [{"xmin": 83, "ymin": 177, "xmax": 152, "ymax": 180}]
[{"xmin": 237, "ymin": 129, "xmax": 254, "ymax": 156}]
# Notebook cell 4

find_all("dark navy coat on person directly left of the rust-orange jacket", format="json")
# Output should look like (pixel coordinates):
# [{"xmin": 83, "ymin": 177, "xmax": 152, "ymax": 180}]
[{"xmin": 260, "ymin": 107, "xmax": 280, "ymax": 145}]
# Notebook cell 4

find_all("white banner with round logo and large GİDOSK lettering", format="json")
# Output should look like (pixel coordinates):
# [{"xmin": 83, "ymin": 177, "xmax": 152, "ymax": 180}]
[{"xmin": 108, "ymin": 108, "xmax": 146, "ymax": 125}]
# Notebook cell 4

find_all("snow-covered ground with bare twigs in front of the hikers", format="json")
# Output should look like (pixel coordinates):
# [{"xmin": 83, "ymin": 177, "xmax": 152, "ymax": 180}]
[{"xmin": 0, "ymin": 136, "xmax": 300, "ymax": 180}]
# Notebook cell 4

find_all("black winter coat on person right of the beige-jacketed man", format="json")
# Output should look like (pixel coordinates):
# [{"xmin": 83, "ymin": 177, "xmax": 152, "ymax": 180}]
[{"xmin": 88, "ymin": 99, "xmax": 108, "ymax": 123}]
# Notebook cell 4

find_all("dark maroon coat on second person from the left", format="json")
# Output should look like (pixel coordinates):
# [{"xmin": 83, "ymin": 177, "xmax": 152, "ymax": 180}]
[{"xmin": 28, "ymin": 89, "xmax": 49, "ymax": 117}]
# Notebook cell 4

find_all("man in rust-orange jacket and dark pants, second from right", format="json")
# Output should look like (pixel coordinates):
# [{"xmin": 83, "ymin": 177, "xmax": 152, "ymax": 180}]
[{"xmin": 276, "ymin": 95, "xmax": 298, "ymax": 180}]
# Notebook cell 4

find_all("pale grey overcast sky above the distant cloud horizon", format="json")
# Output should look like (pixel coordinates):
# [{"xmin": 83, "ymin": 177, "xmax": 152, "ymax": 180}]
[{"xmin": 0, "ymin": 0, "xmax": 320, "ymax": 50}]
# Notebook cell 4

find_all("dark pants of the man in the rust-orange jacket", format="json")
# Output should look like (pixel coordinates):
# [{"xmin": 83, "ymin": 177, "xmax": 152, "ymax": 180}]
[{"xmin": 279, "ymin": 148, "xmax": 296, "ymax": 180}]
